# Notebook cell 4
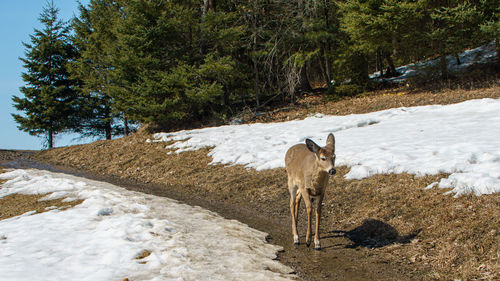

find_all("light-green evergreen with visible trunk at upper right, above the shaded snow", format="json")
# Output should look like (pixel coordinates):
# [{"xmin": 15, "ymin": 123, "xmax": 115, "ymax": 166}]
[{"xmin": 339, "ymin": 0, "xmax": 422, "ymax": 77}]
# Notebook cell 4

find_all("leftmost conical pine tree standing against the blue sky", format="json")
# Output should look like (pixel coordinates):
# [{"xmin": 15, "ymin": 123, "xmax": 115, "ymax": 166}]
[{"xmin": 12, "ymin": 2, "xmax": 79, "ymax": 149}]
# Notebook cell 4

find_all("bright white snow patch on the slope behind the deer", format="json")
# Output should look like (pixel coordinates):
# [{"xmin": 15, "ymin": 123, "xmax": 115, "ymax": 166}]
[{"xmin": 152, "ymin": 99, "xmax": 500, "ymax": 196}]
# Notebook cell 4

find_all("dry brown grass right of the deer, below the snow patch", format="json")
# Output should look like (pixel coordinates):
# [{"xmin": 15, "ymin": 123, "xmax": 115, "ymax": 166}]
[{"xmin": 326, "ymin": 168, "xmax": 500, "ymax": 280}]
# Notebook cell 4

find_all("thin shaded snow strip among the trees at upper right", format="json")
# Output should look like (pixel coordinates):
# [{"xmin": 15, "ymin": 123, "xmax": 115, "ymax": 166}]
[{"xmin": 370, "ymin": 41, "xmax": 497, "ymax": 83}]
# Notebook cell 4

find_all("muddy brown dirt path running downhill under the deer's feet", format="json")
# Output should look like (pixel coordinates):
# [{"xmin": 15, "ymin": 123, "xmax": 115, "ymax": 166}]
[{"xmin": 0, "ymin": 151, "xmax": 421, "ymax": 280}]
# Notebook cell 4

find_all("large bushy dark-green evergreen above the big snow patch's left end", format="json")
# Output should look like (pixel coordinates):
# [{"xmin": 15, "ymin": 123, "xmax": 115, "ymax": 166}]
[{"xmin": 109, "ymin": 1, "xmax": 245, "ymax": 126}]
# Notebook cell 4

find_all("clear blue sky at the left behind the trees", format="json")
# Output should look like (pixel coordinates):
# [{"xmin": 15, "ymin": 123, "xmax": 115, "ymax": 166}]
[{"xmin": 0, "ymin": 0, "xmax": 89, "ymax": 150}]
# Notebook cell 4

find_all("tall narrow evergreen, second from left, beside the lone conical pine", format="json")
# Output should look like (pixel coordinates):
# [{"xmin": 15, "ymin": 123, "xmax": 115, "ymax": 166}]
[{"xmin": 70, "ymin": 0, "xmax": 122, "ymax": 139}]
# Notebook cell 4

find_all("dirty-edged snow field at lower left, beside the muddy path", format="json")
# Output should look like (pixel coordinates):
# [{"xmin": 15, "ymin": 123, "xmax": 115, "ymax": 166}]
[{"xmin": 0, "ymin": 170, "xmax": 292, "ymax": 281}]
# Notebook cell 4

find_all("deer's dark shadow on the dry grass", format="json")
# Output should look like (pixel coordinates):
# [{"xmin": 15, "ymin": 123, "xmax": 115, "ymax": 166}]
[{"xmin": 322, "ymin": 219, "xmax": 421, "ymax": 248}]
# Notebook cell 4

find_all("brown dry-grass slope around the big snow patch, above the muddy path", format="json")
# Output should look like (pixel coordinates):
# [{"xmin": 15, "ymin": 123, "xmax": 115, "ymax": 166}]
[{"xmin": 38, "ymin": 85, "xmax": 500, "ymax": 280}]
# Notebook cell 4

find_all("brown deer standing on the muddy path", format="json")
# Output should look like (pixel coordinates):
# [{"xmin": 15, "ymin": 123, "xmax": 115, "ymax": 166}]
[{"xmin": 285, "ymin": 133, "xmax": 337, "ymax": 250}]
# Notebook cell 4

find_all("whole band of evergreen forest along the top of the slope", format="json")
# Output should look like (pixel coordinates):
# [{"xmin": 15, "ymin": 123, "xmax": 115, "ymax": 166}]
[{"xmin": 13, "ymin": 0, "xmax": 500, "ymax": 148}]
